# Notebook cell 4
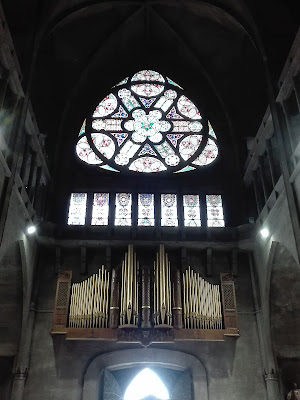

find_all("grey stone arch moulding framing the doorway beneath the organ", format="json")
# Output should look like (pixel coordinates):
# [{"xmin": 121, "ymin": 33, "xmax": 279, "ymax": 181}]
[{"xmin": 82, "ymin": 348, "xmax": 208, "ymax": 400}]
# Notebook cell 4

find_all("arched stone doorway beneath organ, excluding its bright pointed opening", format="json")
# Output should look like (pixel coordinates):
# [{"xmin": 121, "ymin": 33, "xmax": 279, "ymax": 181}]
[{"xmin": 82, "ymin": 348, "xmax": 208, "ymax": 400}]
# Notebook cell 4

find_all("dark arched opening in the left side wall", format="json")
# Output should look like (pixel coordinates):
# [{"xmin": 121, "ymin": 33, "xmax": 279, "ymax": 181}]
[{"xmin": 0, "ymin": 241, "xmax": 23, "ymax": 357}]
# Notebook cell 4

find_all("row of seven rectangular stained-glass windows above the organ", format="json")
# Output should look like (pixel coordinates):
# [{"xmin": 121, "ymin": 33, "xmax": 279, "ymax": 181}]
[{"xmin": 68, "ymin": 193, "xmax": 225, "ymax": 228}]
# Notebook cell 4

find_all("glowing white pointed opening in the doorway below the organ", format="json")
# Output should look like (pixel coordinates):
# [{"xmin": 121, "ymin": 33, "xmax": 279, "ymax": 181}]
[{"xmin": 124, "ymin": 368, "xmax": 169, "ymax": 400}]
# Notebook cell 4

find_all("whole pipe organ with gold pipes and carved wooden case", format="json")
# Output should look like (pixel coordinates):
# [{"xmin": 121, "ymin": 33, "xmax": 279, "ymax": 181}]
[{"xmin": 51, "ymin": 245, "xmax": 239, "ymax": 346}]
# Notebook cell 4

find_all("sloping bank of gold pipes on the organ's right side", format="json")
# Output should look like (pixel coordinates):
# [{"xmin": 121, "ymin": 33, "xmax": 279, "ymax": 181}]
[{"xmin": 182, "ymin": 267, "xmax": 222, "ymax": 329}]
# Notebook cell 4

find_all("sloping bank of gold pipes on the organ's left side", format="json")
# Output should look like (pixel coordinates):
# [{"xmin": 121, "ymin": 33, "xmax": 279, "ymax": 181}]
[{"xmin": 69, "ymin": 265, "xmax": 110, "ymax": 328}]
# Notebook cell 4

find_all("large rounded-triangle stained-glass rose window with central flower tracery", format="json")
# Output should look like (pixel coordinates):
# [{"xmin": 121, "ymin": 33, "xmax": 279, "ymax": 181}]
[{"xmin": 76, "ymin": 70, "xmax": 218, "ymax": 173}]
